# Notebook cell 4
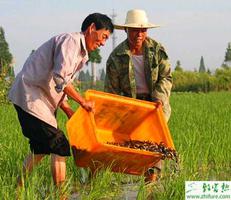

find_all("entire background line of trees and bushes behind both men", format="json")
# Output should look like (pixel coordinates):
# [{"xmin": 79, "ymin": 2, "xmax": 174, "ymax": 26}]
[{"xmin": 0, "ymin": 27, "xmax": 231, "ymax": 103}]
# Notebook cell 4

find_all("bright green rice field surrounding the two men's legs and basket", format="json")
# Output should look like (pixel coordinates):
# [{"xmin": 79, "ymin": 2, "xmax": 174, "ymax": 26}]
[{"xmin": 0, "ymin": 92, "xmax": 231, "ymax": 200}]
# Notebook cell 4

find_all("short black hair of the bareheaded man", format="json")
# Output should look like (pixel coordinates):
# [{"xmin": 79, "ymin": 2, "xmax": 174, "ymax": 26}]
[{"xmin": 81, "ymin": 13, "xmax": 114, "ymax": 33}]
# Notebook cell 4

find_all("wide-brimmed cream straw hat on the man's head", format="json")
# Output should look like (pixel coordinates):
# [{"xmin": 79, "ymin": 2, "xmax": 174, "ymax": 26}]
[{"xmin": 114, "ymin": 9, "xmax": 159, "ymax": 30}]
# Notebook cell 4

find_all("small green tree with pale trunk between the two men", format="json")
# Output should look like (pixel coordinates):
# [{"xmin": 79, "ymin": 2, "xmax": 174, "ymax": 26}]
[{"xmin": 89, "ymin": 49, "xmax": 102, "ymax": 86}]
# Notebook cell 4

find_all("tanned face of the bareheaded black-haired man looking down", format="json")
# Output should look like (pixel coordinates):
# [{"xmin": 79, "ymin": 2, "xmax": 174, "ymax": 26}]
[{"xmin": 85, "ymin": 24, "xmax": 111, "ymax": 52}]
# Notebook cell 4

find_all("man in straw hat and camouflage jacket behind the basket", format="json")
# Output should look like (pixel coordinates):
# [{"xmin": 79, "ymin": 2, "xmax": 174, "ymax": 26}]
[{"xmin": 105, "ymin": 9, "xmax": 172, "ymax": 181}]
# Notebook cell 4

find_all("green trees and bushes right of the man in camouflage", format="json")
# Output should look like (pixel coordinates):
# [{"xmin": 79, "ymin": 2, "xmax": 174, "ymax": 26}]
[{"xmin": 172, "ymin": 43, "xmax": 231, "ymax": 92}]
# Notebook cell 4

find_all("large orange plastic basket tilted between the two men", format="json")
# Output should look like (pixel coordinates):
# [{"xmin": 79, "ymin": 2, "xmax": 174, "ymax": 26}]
[{"xmin": 67, "ymin": 90, "xmax": 174, "ymax": 175}]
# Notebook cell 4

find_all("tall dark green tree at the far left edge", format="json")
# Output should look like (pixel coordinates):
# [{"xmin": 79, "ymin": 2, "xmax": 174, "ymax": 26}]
[{"xmin": 0, "ymin": 27, "xmax": 13, "ymax": 77}]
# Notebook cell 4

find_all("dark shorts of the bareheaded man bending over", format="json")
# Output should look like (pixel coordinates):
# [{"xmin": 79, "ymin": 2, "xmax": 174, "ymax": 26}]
[{"xmin": 14, "ymin": 105, "xmax": 70, "ymax": 156}]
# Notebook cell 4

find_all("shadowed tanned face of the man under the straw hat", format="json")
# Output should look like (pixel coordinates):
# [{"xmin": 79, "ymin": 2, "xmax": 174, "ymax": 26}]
[{"xmin": 127, "ymin": 28, "xmax": 147, "ymax": 49}]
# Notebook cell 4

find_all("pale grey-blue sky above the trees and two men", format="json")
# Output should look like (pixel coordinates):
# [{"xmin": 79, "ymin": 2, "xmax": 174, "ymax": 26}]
[{"xmin": 0, "ymin": 0, "xmax": 231, "ymax": 73}]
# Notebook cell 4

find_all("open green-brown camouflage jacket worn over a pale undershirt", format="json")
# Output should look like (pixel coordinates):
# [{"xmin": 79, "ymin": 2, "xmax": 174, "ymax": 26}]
[{"xmin": 104, "ymin": 38, "xmax": 172, "ymax": 120}]
